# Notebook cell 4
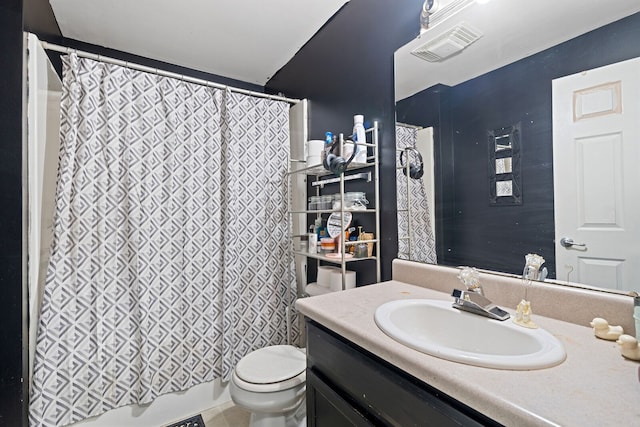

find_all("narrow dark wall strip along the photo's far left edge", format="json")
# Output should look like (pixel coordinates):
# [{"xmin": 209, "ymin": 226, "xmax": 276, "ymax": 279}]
[{"xmin": 0, "ymin": 0, "xmax": 26, "ymax": 426}]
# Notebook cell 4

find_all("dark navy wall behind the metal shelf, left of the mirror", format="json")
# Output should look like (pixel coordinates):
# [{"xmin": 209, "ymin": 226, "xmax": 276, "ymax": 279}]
[{"xmin": 266, "ymin": 0, "xmax": 423, "ymax": 283}]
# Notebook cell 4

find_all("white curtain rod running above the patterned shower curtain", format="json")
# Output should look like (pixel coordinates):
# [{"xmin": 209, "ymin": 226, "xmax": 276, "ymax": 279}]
[{"xmin": 40, "ymin": 41, "xmax": 300, "ymax": 104}]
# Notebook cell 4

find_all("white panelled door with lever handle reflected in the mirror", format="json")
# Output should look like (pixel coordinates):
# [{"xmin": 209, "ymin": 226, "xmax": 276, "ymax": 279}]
[{"xmin": 553, "ymin": 58, "xmax": 640, "ymax": 290}]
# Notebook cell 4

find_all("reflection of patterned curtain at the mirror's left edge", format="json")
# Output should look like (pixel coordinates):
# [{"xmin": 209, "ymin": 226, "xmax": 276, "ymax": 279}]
[{"xmin": 396, "ymin": 125, "xmax": 437, "ymax": 264}]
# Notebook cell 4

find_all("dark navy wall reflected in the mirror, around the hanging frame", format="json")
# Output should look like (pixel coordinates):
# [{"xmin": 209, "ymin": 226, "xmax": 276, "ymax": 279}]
[{"xmin": 397, "ymin": 14, "xmax": 640, "ymax": 277}]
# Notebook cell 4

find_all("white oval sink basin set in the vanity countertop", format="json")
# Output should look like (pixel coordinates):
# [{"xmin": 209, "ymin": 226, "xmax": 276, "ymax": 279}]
[{"xmin": 375, "ymin": 299, "xmax": 566, "ymax": 370}]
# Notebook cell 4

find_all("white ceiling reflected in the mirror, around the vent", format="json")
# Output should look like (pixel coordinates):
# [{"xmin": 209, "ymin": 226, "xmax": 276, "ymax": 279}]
[{"xmin": 395, "ymin": 0, "xmax": 640, "ymax": 101}]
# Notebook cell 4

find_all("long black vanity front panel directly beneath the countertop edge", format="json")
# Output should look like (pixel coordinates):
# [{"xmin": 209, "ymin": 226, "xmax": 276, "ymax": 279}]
[{"xmin": 307, "ymin": 320, "xmax": 500, "ymax": 427}]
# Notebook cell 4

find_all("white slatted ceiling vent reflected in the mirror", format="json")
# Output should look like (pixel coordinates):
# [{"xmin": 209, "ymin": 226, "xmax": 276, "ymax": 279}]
[{"xmin": 411, "ymin": 22, "xmax": 482, "ymax": 62}]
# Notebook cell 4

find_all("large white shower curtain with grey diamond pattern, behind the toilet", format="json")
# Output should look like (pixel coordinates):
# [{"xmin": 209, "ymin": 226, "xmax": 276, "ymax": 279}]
[{"xmin": 30, "ymin": 54, "xmax": 299, "ymax": 426}]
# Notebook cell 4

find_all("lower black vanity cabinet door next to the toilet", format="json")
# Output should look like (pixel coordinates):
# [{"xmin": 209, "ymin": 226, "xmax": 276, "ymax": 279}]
[{"xmin": 307, "ymin": 369, "xmax": 374, "ymax": 427}]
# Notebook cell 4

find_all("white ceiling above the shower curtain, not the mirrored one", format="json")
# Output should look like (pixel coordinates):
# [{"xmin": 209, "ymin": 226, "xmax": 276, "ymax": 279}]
[{"xmin": 50, "ymin": 0, "xmax": 348, "ymax": 86}]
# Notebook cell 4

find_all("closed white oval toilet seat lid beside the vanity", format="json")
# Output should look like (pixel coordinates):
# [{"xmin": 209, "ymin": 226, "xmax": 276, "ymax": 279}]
[{"xmin": 236, "ymin": 345, "xmax": 307, "ymax": 384}]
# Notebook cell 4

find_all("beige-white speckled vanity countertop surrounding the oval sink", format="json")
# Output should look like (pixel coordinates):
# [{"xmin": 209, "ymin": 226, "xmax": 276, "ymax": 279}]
[{"xmin": 296, "ymin": 281, "xmax": 640, "ymax": 427}]
